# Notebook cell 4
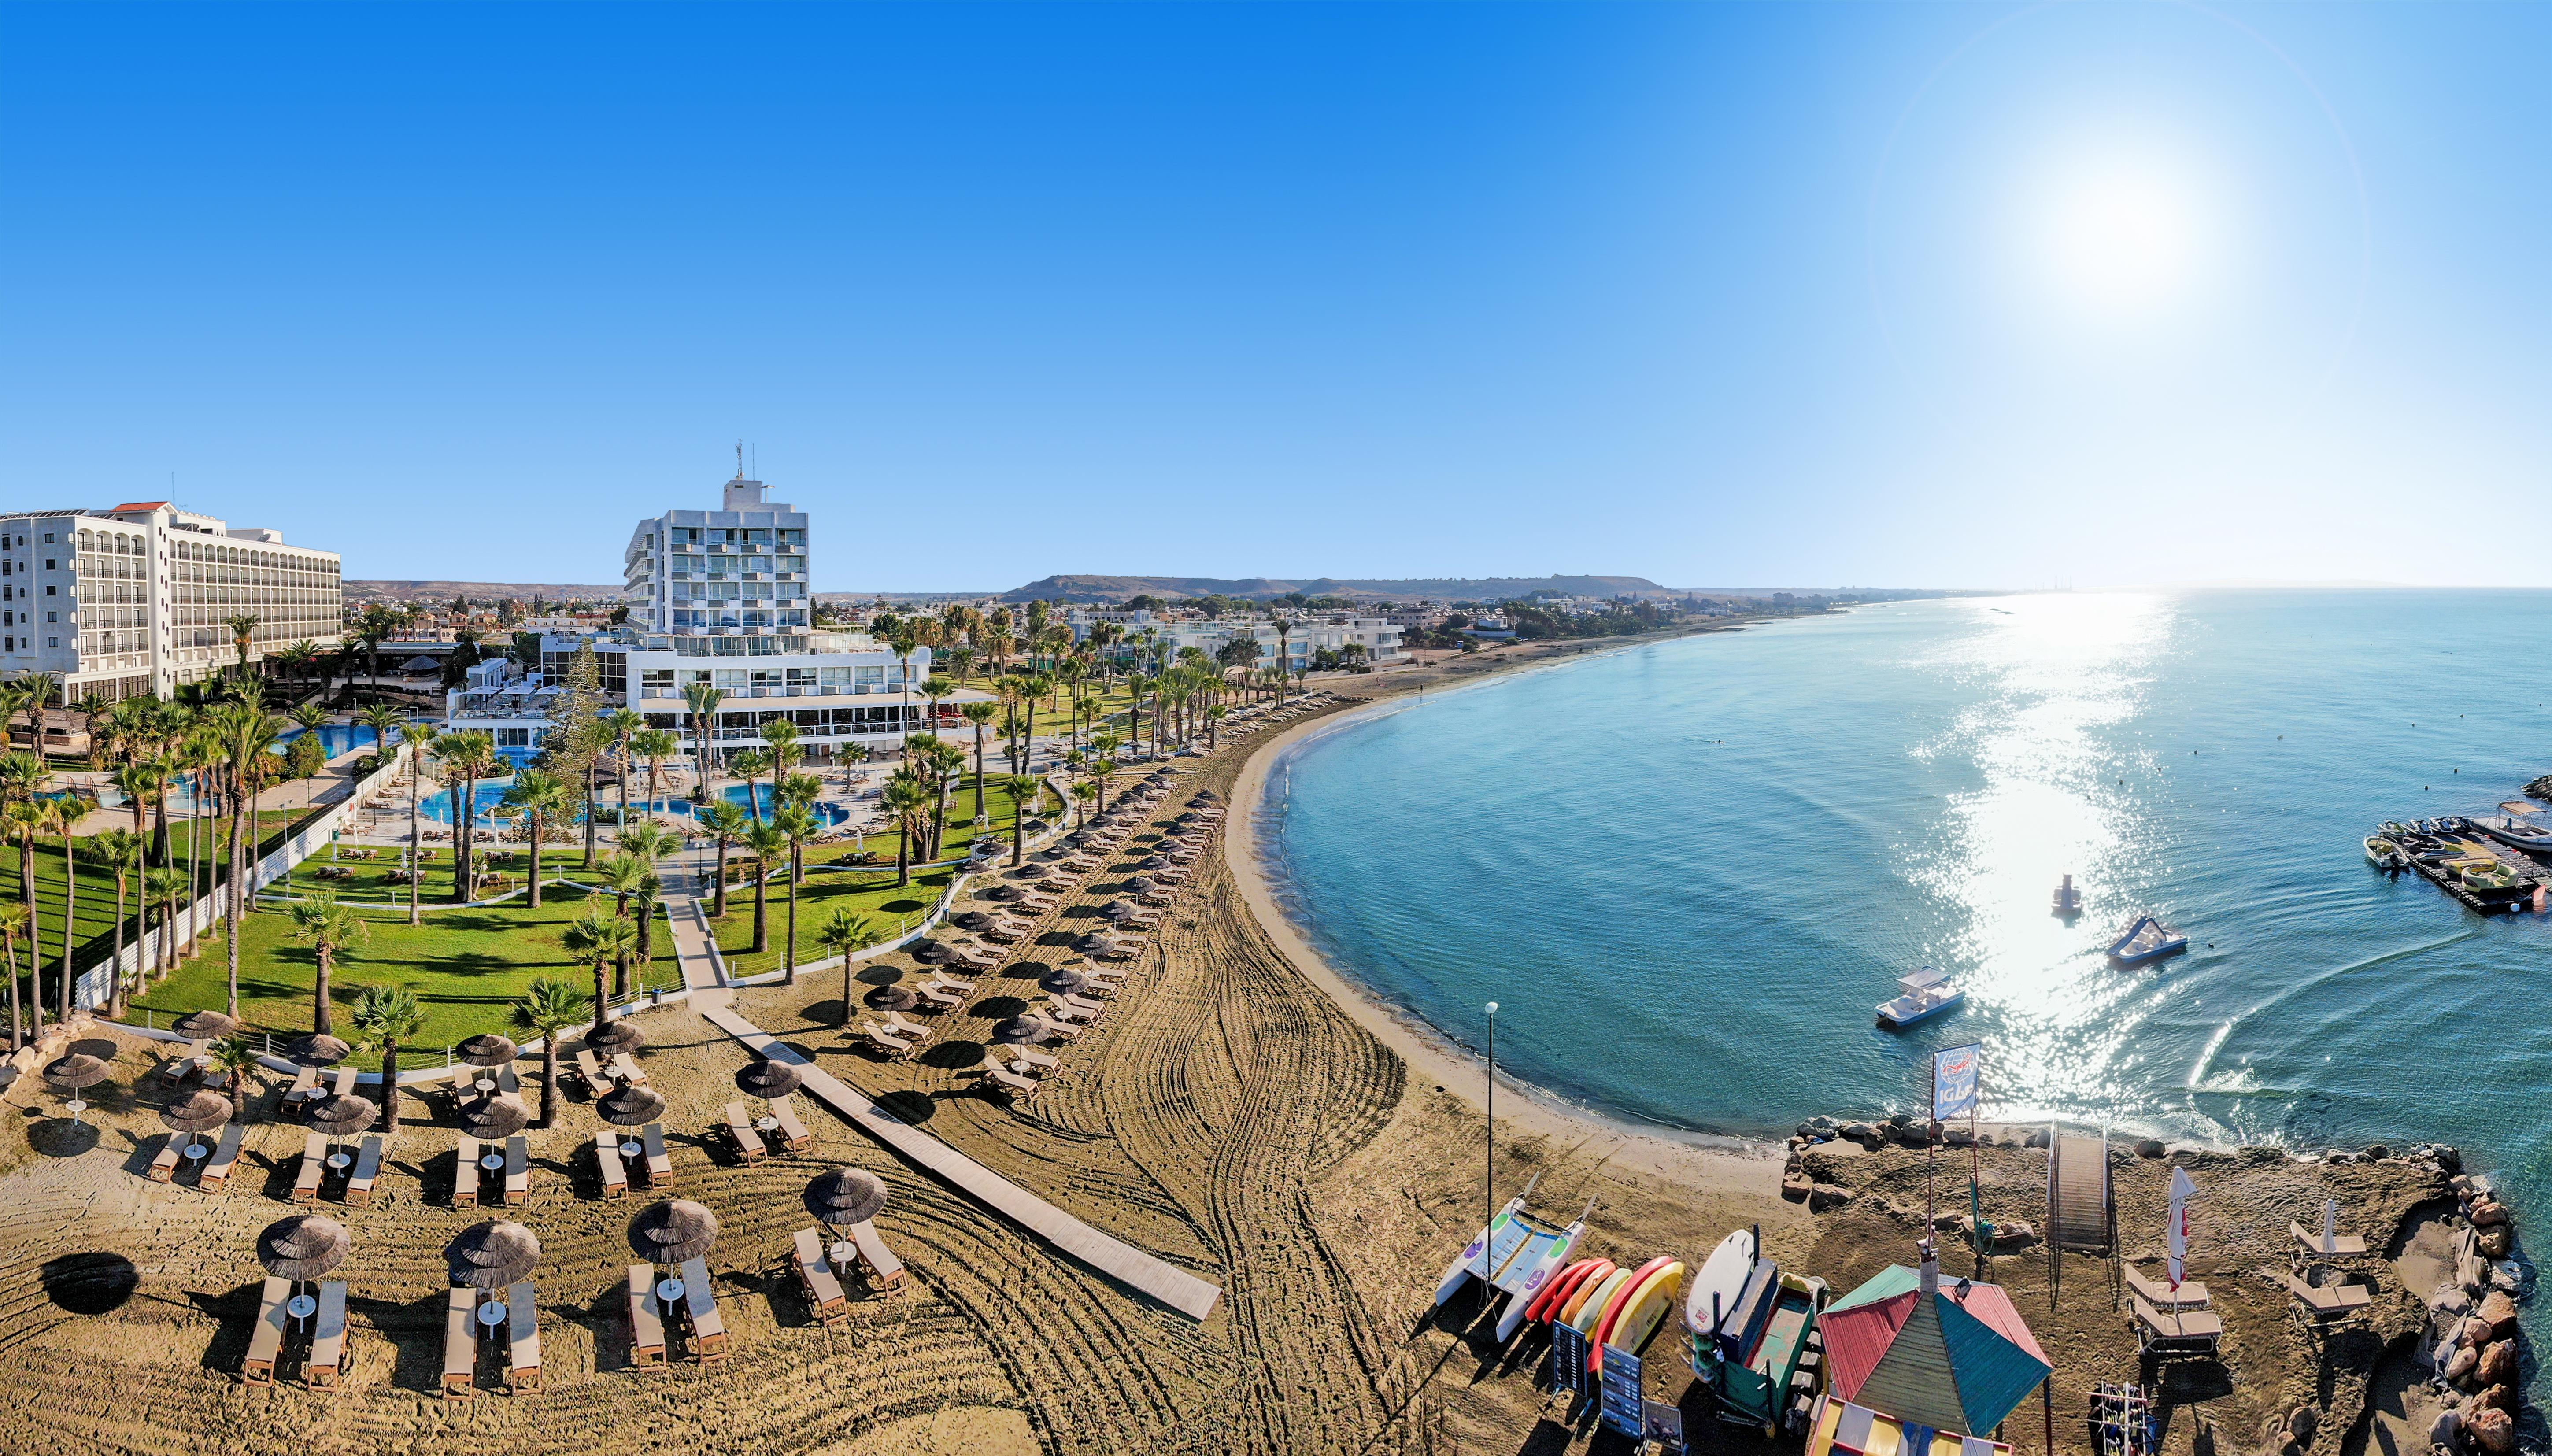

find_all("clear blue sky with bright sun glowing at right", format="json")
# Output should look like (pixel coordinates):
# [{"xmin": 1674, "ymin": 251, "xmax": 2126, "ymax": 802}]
[{"xmin": 0, "ymin": 3, "xmax": 2552, "ymax": 589}]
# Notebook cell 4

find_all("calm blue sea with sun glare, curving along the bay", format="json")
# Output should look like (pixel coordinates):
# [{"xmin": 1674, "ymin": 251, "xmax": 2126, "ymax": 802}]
[{"xmin": 1258, "ymin": 589, "xmax": 2552, "ymax": 1188}]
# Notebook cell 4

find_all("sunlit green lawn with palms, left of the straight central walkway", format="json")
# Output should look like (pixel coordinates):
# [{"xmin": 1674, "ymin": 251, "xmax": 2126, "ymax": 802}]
[{"xmin": 135, "ymin": 887, "xmax": 681, "ymax": 1048}]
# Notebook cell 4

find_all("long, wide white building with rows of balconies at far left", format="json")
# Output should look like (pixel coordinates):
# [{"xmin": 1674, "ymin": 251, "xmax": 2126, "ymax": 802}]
[{"xmin": 0, "ymin": 500, "xmax": 344, "ymax": 701}]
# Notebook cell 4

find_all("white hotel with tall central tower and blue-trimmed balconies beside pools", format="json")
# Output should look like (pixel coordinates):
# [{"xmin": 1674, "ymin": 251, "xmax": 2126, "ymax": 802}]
[{"xmin": 447, "ymin": 477, "xmax": 985, "ymax": 762}]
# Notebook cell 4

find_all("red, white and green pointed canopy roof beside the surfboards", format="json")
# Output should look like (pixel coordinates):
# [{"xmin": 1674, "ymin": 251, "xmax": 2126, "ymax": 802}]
[{"xmin": 1822, "ymin": 1247, "xmax": 2052, "ymax": 1436}]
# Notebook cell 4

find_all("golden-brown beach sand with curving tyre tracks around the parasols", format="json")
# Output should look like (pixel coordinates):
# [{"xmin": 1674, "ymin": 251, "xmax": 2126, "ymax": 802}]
[{"xmin": 0, "ymin": 632, "xmax": 2434, "ymax": 1456}]
